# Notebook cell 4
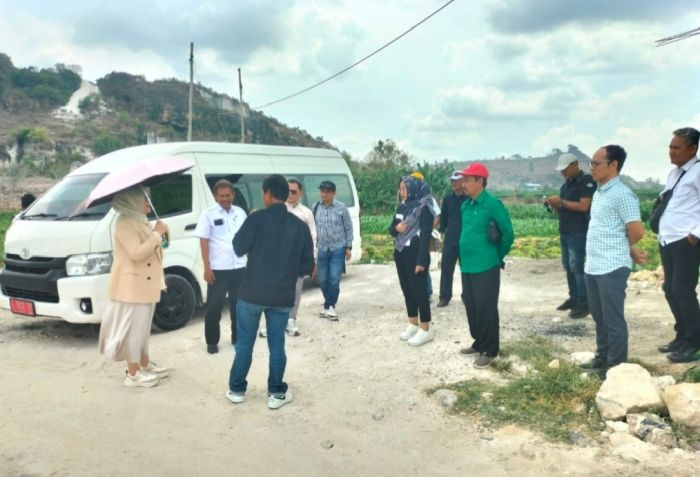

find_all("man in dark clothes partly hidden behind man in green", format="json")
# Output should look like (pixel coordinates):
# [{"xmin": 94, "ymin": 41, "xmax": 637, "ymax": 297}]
[{"xmin": 438, "ymin": 171, "xmax": 467, "ymax": 307}]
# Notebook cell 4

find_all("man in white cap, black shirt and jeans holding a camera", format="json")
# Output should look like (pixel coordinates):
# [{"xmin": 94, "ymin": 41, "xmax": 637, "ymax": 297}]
[{"xmin": 546, "ymin": 152, "xmax": 596, "ymax": 318}]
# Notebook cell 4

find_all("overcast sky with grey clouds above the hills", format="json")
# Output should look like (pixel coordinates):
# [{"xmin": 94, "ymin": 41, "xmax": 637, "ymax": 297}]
[{"xmin": 0, "ymin": 0, "xmax": 700, "ymax": 179}]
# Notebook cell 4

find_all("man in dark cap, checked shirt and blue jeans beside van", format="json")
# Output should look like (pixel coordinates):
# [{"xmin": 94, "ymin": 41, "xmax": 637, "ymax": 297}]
[{"xmin": 314, "ymin": 181, "xmax": 352, "ymax": 321}]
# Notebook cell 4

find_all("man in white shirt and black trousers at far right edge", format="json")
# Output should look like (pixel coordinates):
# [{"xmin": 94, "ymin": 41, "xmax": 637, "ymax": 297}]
[{"xmin": 659, "ymin": 128, "xmax": 700, "ymax": 363}]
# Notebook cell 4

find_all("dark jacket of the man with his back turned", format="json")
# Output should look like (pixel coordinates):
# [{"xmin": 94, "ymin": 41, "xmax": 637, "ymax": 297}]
[{"xmin": 233, "ymin": 203, "xmax": 314, "ymax": 307}]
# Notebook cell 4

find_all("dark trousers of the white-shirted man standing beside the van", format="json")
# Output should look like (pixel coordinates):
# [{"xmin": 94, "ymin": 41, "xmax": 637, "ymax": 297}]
[{"xmin": 204, "ymin": 268, "xmax": 245, "ymax": 345}]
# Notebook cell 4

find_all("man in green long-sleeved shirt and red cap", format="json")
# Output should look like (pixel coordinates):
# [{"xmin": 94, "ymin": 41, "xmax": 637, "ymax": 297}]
[{"xmin": 459, "ymin": 162, "xmax": 514, "ymax": 368}]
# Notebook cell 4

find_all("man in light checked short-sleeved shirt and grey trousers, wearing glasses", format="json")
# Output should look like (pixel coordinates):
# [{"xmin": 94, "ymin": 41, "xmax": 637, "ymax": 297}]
[{"xmin": 584, "ymin": 145, "xmax": 646, "ymax": 379}]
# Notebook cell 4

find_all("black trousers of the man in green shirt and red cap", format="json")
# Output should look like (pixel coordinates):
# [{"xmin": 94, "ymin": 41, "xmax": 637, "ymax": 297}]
[{"xmin": 462, "ymin": 267, "xmax": 501, "ymax": 358}]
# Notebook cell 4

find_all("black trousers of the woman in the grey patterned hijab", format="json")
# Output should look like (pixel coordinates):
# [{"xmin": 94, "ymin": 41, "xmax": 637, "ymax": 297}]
[{"xmin": 394, "ymin": 244, "xmax": 431, "ymax": 323}]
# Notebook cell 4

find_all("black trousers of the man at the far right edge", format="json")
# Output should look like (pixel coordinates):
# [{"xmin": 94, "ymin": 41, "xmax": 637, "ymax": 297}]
[{"xmin": 660, "ymin": 238, "xmax": 700, "ymax": 346}]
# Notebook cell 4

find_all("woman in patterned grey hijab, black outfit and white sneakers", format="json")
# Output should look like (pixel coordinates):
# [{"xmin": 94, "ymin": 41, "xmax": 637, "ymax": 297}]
[{"xmin": 389, "ymin": 176, "xmax": 434, "ymax": 346}]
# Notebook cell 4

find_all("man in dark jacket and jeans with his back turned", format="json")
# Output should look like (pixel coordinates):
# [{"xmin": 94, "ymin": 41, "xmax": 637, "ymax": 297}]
[{"xmin": 226, "ymin": 174, "xmax": 314, "ymax": 409}]
